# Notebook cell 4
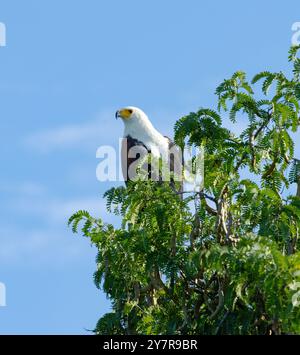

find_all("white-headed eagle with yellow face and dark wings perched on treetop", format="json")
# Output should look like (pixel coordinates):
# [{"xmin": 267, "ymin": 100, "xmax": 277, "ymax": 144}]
[{"xmin": 116, "ymin": 106, "xmax": 183, "ymax": 186}]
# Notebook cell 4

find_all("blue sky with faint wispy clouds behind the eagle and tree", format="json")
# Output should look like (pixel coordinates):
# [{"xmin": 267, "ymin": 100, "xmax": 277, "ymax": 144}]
[{"xmin": 0, "ymin": 0, "xmax": 300, "ymax": 334}]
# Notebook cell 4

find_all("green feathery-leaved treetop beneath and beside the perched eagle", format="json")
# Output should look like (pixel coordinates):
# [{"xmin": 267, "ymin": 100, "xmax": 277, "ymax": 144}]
[{"xmin": 69, "ymin": 46, "xmax": 300, "ymax": 334}]
